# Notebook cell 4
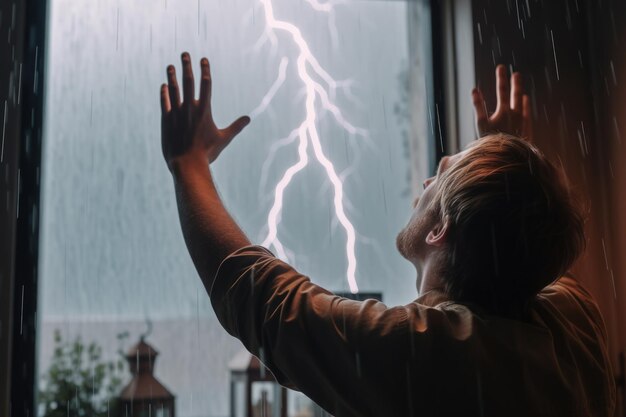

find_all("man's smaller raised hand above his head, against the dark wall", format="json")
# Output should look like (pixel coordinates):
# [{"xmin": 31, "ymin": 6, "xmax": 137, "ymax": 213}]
[{"xmin": 472, "ymin": 65, "xmax": 532, "ymax": 140}]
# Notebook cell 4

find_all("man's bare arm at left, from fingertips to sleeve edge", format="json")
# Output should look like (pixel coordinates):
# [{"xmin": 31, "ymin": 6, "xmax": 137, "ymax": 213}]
[{"xmin": 161, "ymin": 52, "xmax": 250, "ymax": 291}]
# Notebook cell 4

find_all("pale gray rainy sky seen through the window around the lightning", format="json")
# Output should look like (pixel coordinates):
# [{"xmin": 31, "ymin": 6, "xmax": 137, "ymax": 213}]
[{"xmin": 40, "ymin": 0, "xmax": 416, "ymax": 320}]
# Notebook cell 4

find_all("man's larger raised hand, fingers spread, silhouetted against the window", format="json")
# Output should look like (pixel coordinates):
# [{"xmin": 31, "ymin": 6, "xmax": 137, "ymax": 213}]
[{"xmin": 161, "ymin": 52, "xmax": 250, "ymax": 171}]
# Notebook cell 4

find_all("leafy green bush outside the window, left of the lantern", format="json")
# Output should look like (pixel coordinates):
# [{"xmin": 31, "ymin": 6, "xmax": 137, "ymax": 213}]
[{"xmin": 38, "ymin": 330, "xmax": 127, "ymax": 417}]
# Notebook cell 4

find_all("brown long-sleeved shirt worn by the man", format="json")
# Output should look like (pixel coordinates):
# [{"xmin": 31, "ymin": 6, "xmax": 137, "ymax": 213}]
[{"xmin": 210, "ymin": 246, "xmax": 615, "ymax": 417}]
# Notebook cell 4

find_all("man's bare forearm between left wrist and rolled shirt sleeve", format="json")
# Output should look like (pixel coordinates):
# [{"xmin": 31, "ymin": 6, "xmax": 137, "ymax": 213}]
[{"xmin": 172, "ymin": 160, "xmax": 250, "ymax": 291}]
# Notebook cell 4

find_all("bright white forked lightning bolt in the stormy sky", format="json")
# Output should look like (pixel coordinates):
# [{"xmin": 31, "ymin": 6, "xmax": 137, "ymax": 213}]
[{"xmin": 252, "ymin": 0, "xmax": 367, "ymax": 293}]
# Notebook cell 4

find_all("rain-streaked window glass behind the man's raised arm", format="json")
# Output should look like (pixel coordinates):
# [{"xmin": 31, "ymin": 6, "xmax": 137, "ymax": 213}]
[{"xmin": 38, "ymin": 0, "xmax": 426, "ymax": 417}]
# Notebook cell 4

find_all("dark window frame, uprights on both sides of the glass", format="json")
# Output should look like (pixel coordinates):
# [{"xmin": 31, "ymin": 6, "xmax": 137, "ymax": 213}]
[{"xmin": 0, "ymin": 0, "xmax": 456, "ymax": 415}]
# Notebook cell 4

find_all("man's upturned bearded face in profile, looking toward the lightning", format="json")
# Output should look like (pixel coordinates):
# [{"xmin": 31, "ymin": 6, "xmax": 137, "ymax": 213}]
[{"xmin": 396, "ymin": 151, "xmax": 467, "ymax": 264}]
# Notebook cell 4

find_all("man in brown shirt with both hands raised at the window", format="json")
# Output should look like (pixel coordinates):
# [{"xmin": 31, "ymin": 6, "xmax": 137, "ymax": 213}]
[{"xmin": 161, "ymin": 53, "xmax": 615, "ymax": 417}]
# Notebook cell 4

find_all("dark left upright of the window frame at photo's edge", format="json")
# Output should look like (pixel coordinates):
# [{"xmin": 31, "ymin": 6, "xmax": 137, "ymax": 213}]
[{"xmin": 0, "ymin": 0, "xmax": 47, "ymax": 415}]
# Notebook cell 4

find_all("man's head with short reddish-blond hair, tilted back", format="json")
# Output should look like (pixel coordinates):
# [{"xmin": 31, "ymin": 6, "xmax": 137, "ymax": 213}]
[{"xmin": 398, "ymin": 134, "xmax": 585, "ymax": 314}]
